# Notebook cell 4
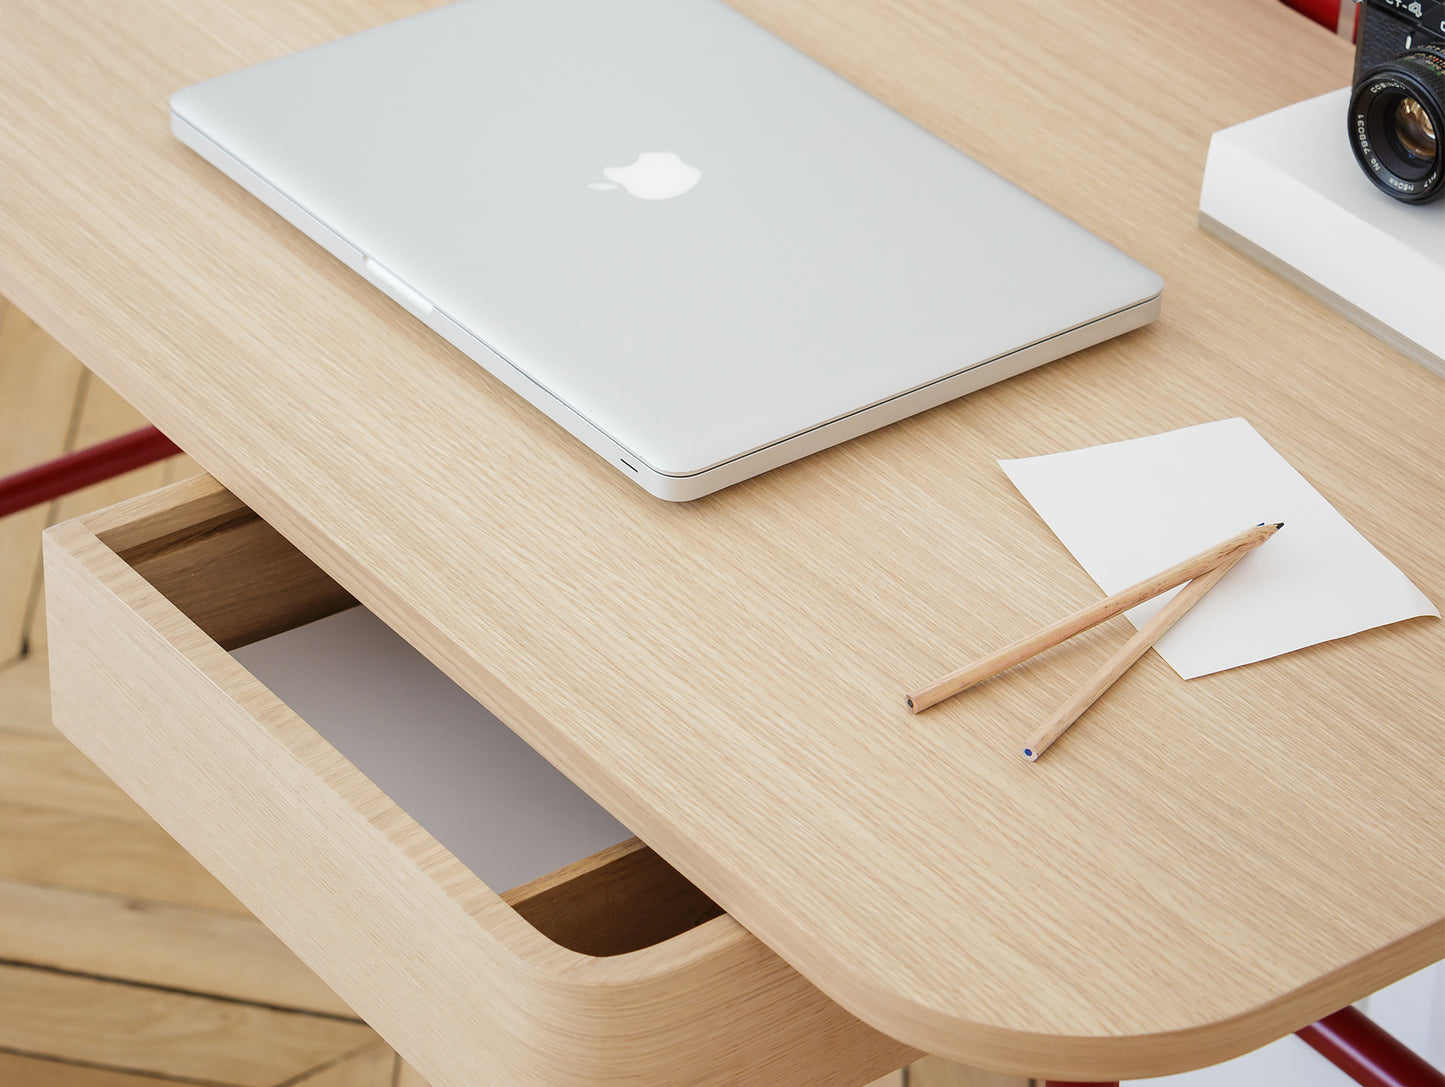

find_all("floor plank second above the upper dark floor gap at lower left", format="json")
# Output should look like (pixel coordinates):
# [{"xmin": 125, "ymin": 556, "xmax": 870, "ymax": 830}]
[{"xmin": 0, "ymin": 801, "xmax": 250, "ymax": 916}]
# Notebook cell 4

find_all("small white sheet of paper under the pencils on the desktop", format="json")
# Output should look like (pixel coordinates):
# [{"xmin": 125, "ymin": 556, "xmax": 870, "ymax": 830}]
[{"xmin": 998, "ymin": 419, "xmax": 1439, "ymax": 679}]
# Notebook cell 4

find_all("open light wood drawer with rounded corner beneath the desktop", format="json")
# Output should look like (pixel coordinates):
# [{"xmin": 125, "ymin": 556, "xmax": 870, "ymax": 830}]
[{"xmin": 45, "ymin": 477, "xmax": 916, "ymax": 1087}]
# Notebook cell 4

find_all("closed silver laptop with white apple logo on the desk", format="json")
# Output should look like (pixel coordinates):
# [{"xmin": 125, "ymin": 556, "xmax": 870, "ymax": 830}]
[{"xmin": 171, "ymin": 0, "xmax": 1162, "ymax": 500}]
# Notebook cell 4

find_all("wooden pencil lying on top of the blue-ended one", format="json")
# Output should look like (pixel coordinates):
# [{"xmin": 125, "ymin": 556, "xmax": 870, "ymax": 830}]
[{"xmin": 906, "ymin": 522, "xmax": 1283, "ymax": 713}]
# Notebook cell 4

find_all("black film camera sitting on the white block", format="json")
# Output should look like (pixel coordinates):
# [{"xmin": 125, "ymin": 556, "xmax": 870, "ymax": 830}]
[{"xmin": 1348, "ymin": 0, "xmax": 1445, "ymax": 204}]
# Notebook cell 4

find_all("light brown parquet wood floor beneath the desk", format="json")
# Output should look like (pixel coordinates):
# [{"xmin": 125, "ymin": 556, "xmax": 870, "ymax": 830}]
[{"xmin": 0, "ymin": 290, "xmax": 994, "ymax": 1087}]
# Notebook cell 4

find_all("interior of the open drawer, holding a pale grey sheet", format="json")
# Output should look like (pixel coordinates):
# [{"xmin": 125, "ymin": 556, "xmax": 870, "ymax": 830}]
[{"xmin": 97, "ymin": 496, "xmax": 723, "ymax": 955}]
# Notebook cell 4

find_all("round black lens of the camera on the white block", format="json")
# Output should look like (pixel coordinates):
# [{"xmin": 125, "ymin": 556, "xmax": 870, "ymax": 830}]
[{"xmin": 1348, "ymin": 45, "xmax": 1445, "ymax": 204}]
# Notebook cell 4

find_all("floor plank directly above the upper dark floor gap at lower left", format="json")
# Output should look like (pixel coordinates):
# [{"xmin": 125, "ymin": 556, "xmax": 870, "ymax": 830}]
[{"xmin": 0, "ymin": 880, "xmax": 353, "ymax": 1016}]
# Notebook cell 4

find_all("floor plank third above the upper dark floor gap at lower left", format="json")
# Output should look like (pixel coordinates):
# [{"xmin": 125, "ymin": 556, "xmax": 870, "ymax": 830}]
[{"xmin": 0, "ymin": 733, "xmax": 152, "ymax": 822}]
